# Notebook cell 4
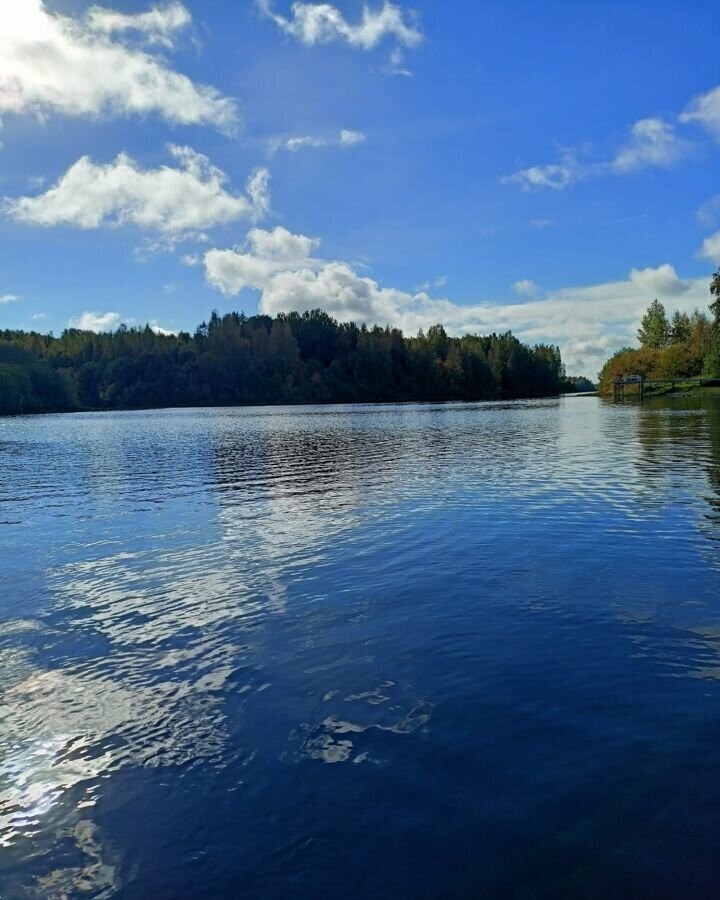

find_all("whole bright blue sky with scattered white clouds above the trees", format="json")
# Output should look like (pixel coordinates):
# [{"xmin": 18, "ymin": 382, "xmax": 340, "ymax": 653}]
[{"xmin": 0, "ymin": 0, "xmax": 720, "ymax": 377}]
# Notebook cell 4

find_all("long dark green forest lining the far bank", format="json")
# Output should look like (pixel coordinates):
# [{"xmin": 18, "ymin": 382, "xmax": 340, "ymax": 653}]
[{"xmin": 0, "ymin": 310, "xmax": 572, "ymax": 413}]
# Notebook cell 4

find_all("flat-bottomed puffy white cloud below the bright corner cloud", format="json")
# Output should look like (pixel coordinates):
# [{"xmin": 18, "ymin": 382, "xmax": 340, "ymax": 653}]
[{"xmin": 4, "ymin": 146, "xmax": 269, "ymax": 242}]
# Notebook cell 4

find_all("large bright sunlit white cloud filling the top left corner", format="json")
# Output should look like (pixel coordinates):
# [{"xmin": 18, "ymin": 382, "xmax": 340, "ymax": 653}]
[{"xmin": 0, "ymin": 0, "xmax": 237, "ymax": 131}]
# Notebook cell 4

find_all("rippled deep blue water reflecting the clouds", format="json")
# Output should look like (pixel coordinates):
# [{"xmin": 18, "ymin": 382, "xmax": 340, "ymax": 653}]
[{"xmin": 0, "ymin": 398, "xmax": 720, "ymax": 900}]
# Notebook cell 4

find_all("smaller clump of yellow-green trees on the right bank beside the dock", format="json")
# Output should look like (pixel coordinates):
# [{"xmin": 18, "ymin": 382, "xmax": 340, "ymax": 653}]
[{"xmin": 599, "ymin": 270, "xmax": 720, "ymax": 393}]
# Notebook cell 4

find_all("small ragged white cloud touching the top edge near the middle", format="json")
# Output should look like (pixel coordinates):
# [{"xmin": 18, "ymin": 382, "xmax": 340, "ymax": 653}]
[{"xmin": 257, "ymin": 0, "xmax": 422, "ymax": 50}]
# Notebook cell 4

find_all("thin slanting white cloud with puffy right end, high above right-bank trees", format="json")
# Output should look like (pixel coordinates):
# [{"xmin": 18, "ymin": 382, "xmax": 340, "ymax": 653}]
[{"xmin": 500, "ymin": 118, "xmax": 691, "ymax": 191}]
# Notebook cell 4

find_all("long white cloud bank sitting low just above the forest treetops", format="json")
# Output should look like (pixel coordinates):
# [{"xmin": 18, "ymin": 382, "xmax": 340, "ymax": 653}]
[{"xmin": 203, "ymin": 228, "xmax": 709, "ymax": 377}]
